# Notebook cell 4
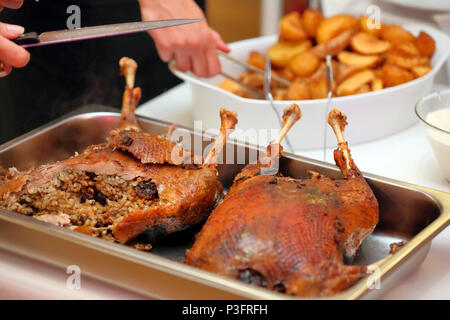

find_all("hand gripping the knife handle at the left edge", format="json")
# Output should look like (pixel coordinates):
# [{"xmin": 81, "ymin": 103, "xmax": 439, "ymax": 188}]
[{"xmin": 0, "ymin": 0, "xmax": 30, "ymax": 75}]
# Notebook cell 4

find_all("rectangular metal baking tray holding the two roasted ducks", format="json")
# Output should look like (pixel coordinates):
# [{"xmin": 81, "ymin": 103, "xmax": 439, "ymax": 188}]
[{"xmin": 0, "ymin": 106, "xmax": 450, "ymax": 299}]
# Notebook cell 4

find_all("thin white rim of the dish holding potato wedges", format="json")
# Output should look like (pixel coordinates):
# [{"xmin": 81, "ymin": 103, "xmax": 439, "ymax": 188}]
[{"xmin": 169, "ymin": 23, "xmax": 450, "ymax": 106}]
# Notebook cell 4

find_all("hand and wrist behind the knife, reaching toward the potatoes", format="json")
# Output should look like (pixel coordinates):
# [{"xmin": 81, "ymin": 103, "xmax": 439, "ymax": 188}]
[{"xmin": 139, "ymin": 0, "xmax": 229, "ymax": 77}]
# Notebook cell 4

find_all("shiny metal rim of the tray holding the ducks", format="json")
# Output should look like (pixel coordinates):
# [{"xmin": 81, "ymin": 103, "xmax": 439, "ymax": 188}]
[{"xmin": 0, "ymin": 105, "xmax": 450, "ymax": 300}]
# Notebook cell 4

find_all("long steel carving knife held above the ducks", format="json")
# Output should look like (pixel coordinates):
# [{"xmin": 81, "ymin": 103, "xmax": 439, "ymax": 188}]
[{"xmin": 13, "ymin": 19, "xmax": 204, "ymax": 48}]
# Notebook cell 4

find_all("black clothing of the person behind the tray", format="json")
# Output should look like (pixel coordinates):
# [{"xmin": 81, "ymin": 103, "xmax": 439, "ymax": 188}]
[{"xmin": 0, "ymin": 0, "xmax": 204, "ymax": 143}]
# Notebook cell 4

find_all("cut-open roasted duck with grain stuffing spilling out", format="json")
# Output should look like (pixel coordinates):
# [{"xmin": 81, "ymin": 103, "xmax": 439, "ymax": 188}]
[{"xmin": 0, "ymin": 58, "xmax": 236, "ymax": 243}]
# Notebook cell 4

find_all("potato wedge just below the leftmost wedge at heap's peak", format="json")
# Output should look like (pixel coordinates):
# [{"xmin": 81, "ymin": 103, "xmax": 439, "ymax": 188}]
[{"xmin": 267, "ymin": 40, "xmax": 312, "ymax": 67}]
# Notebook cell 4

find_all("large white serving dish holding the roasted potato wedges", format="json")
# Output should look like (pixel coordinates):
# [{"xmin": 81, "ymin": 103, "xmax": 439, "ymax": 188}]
[{"xmin": 170, "ymin": 24, "xmax": 450, "ymax": 151}]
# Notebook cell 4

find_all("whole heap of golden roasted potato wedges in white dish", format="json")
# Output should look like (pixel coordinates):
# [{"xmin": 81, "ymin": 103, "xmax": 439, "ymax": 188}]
[{"xmin": 224, "ymin": 9, "xmax": 436, "ymax": 100}]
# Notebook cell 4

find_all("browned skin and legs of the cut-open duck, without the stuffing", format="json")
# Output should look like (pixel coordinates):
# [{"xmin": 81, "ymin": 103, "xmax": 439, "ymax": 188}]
[{"xmin": 0, "ymin": 58, "xmax": 236, "ymax": 243}]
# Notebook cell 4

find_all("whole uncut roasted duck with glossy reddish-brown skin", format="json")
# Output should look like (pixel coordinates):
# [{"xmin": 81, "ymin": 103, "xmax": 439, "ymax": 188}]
[{"xmin": 185, "ymin": 105, "xmax": 378, "ymax": 297}]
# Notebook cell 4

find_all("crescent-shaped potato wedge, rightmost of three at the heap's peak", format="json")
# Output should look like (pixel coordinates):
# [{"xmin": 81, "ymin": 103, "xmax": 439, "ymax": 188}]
[{"xmin": 316, "ymin": 14, "xmax": 360, "ymax": 44}]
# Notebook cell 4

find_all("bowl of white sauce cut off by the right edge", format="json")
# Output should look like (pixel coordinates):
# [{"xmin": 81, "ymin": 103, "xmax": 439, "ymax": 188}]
[{"xmin": 416, "ymin": 90, "xmax": 450, "ymax": 182}]
